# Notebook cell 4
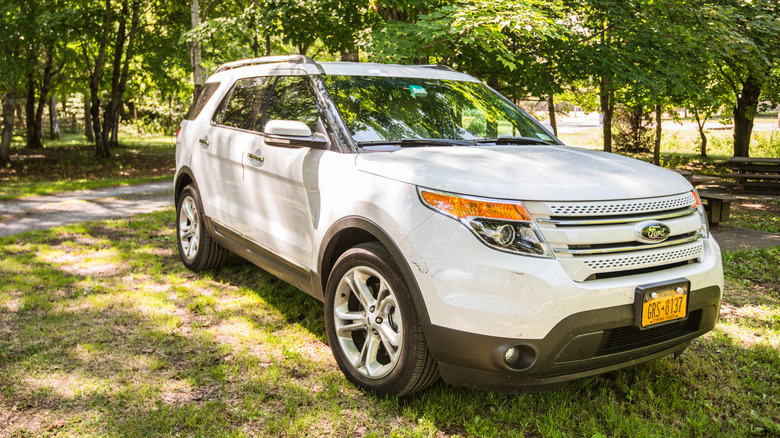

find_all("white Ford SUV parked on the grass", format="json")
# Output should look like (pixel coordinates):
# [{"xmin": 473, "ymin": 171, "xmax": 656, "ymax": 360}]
[{"xmin": 175, "ymin": 56, "xmax": 723, "ymax": 395}]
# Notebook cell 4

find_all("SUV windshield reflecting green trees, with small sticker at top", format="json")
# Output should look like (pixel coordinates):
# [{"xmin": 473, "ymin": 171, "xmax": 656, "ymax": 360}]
[{"xmin": 323, "ymin": 76, "xmax": 557, "ymax": 144}]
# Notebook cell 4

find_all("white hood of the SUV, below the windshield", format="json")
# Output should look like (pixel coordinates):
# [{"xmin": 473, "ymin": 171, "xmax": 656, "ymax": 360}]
[{"xmin": 356, "ymin": 146, "xmax": 691, "ymax": 201}]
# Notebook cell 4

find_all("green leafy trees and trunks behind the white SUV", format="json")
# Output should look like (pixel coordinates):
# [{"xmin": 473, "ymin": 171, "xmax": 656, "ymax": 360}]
[{"xmin": 0, "ymin": 0, "xmax": 780, "ymax": 166}]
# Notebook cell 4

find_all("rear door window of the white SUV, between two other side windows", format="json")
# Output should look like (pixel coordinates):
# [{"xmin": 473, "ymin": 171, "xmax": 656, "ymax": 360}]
[{"xmin": 216, "ymin": 77, "xmax": 271, "ymax": 131}]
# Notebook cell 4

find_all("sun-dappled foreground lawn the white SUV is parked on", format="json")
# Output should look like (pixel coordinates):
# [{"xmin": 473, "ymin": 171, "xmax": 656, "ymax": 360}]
[{"xmin": 0, "ymin": 209, "xmax": 780, "ymax": 437}]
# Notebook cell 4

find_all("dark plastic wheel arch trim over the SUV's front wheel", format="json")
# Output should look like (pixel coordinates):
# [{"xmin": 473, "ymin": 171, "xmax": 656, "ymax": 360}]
[{"xmin": 317, "ymin": 216, "xmax": 430, "ymax": 327}]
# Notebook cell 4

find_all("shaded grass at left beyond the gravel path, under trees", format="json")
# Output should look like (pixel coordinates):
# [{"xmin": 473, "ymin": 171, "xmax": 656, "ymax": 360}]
[{"xmin": 0, "ymin": 134, "xmax": 175, "ymax": 201}]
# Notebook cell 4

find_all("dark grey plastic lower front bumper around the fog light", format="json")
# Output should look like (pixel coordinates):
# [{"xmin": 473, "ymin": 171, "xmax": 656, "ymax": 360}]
[{"xmin": 425, "ymin": 286, "xmax": 721, "ymax": 393}]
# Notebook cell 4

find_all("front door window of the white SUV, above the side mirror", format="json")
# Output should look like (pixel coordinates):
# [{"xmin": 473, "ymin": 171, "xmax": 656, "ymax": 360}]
[{"xmin": 265, "ymin": 76, "xmax": 320, "ymax": 132}]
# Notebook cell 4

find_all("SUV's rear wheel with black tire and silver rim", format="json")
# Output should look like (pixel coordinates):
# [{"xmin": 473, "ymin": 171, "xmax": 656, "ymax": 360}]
[{"xmin": 176, "ymin": 184, "xmax": 229, "ymax": 272}]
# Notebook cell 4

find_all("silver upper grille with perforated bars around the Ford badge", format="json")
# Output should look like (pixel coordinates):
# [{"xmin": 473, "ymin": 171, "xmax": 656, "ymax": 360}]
[{"xmin": 526, "ymin": 192, "xmax": 706, "ymax": 282}]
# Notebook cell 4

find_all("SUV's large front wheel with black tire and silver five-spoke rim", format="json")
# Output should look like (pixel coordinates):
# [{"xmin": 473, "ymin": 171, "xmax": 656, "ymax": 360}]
[{"xmin": 325, "ymin": 242, "xmax": 439, "ymax": 396}]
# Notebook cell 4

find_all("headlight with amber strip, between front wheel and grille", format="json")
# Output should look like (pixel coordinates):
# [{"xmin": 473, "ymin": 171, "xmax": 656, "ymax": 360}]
[{"xmin": 417, "ymin": 187, "xmax": 552, "ymax": 257}]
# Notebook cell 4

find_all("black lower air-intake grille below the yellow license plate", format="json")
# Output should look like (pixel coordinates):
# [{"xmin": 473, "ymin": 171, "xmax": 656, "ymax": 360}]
[{"xmin": 596, "ymin": 310, "xmax": 702, "ymax": 356}]
